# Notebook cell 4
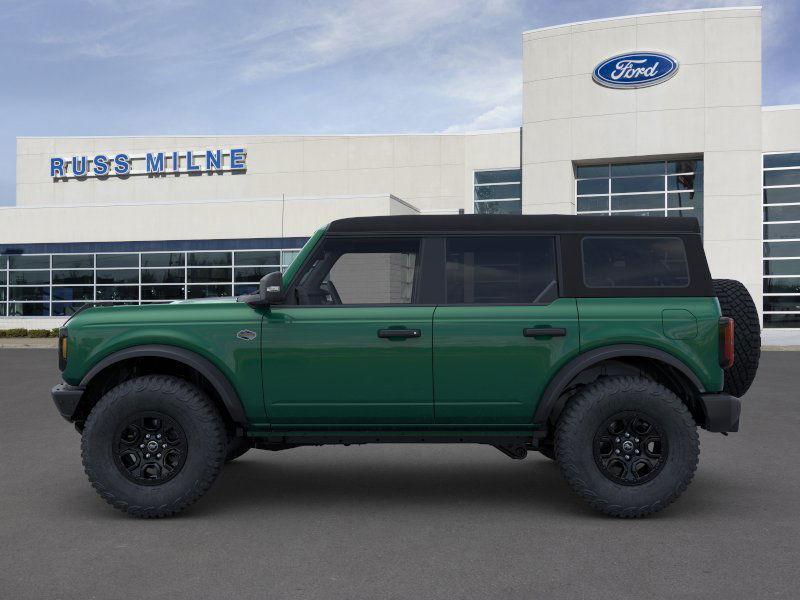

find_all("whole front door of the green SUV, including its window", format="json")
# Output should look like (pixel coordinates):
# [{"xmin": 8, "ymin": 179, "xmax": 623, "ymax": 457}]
[{"xmin": 262, "ymin": 238, "xmax": 433, "ymax": 426}]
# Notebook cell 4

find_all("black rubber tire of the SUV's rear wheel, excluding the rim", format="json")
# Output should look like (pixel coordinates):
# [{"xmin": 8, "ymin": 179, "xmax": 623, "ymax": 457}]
[{"xmin": 556, "ymin": 376, "xmax": 700, "ymax": 518}]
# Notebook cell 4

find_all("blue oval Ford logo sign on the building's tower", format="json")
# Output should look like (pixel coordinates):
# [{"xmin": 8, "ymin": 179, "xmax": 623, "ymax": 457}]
[{"xmin": 592, "ymin": 52, "xmax": 678, "ymax": 88}]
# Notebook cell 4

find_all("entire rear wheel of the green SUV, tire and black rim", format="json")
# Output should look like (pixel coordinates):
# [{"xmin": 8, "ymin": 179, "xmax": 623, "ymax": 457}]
[{"xmin": 556, "ymin": 377, "xmax": 700, "ymax": 518}]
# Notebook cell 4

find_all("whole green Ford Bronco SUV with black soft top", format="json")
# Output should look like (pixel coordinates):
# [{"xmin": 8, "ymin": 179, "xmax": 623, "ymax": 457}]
[{"xmin": 52, "ymin": 215, "xmax": 760, "ymax": 517}]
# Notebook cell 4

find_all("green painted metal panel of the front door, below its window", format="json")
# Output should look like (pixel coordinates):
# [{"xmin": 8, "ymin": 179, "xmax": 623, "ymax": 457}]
[{"xmin": 262, "ymin": 305, "xmax": 433, "ymax": 426}]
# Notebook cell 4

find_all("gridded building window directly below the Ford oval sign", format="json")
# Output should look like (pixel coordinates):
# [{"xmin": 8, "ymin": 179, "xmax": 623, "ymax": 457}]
[{"xmin": 575, "ymin": 159, "xmax": 703, "ymax": 228}]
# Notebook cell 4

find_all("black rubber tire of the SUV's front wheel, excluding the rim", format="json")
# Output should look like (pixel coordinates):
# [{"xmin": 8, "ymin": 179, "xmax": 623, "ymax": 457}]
[{"xmin": 81, "ymin": 375, "xmax": 226, "ymax": 518}]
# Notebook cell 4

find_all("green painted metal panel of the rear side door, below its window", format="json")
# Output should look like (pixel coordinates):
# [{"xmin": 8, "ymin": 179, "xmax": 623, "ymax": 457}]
[{"xmin": 433, "ymin": 298, "xmax": 579, "ymax": 424}]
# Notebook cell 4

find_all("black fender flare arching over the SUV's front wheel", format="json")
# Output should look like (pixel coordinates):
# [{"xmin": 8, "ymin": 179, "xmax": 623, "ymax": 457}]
[{"xmin": 80, "ymin": 344, "xmax": 247, "ymax": 424}]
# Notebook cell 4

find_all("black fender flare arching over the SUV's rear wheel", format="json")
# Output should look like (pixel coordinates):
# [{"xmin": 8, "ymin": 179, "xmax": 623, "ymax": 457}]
[{"xmin": 533, "ymin": 344, "xmax": 705, "ymax": 423}]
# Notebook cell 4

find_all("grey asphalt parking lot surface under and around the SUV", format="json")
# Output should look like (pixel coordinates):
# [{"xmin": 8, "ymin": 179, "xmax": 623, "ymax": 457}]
[{"xmin": 0, "ymin": 349, "xmax": 800, "ymax": 600}]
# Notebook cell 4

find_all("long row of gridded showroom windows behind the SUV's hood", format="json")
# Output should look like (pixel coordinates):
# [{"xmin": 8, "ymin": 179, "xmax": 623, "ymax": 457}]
[{"xmin": 0, "ymin": 249, "xmax": 299, "ymax": 317}]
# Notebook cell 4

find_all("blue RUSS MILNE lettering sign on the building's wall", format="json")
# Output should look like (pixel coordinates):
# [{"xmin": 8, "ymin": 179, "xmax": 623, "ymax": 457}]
[{"xmin": 50, "ymin": 148, "xmax": 247, "ymax": 179}]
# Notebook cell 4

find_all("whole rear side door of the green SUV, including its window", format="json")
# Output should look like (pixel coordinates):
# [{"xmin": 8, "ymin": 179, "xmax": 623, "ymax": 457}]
[{"xmin": 433, "ymin": 235, "xmax": 579, "ymax": 424}]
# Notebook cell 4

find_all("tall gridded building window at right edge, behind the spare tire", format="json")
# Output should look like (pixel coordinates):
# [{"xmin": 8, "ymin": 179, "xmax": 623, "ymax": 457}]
[{"xmin": 763, "ymin": 152, "xmax": 800, "ymax": 329}]
